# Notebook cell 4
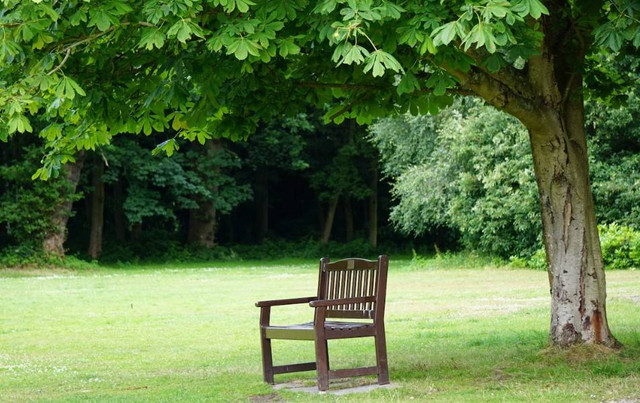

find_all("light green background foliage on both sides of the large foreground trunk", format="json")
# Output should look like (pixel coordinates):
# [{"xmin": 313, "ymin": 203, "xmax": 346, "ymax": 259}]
[{"xmin": 370, "ymin": 92, "xmax": 640, "ymax": 262}]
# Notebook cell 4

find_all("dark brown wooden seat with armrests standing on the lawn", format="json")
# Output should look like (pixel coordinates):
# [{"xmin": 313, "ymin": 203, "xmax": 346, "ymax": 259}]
[{"xmin": 256, "ymin": 255, "xmax": 389, "ymax": 391}]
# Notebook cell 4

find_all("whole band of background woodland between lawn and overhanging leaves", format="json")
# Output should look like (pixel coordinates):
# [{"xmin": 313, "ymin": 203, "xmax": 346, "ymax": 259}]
[{"xmin": 0, "ymin": 91, "xmax": 640, "ymax": 268}]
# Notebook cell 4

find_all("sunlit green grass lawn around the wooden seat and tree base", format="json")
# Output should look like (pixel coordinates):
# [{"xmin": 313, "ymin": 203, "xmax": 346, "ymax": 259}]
[{"xmin": 0, "ymin": 259, "xmax": 640, "ymax": 401}]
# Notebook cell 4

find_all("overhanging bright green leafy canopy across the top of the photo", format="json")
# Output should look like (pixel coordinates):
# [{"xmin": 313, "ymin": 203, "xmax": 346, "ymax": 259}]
[{"xmin": 0, "ymin": 0, "xmax": 640, "ymax": 178}]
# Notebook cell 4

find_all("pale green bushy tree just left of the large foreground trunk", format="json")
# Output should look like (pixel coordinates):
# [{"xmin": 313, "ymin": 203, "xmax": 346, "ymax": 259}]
[{"xmin": 370, "ymin": 100, "xmax": 541, "ymax": 257}]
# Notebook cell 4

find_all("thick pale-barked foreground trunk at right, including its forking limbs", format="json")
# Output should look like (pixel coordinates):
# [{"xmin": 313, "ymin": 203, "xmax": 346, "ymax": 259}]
[{"xmin": 443, "ymin": 15, "xmax": 619, "ymax": 347}]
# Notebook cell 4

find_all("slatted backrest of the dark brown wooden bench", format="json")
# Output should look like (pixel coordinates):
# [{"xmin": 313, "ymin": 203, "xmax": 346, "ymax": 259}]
[{"xmin": 318, "ymin": 255, "xmax": 389, "ymax": 321}]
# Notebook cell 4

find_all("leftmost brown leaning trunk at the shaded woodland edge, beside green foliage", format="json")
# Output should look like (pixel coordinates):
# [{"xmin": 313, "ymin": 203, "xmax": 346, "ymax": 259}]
[{"xmin": 42, "ymin": 152, "xmax": 84, "ymax": 257}]
